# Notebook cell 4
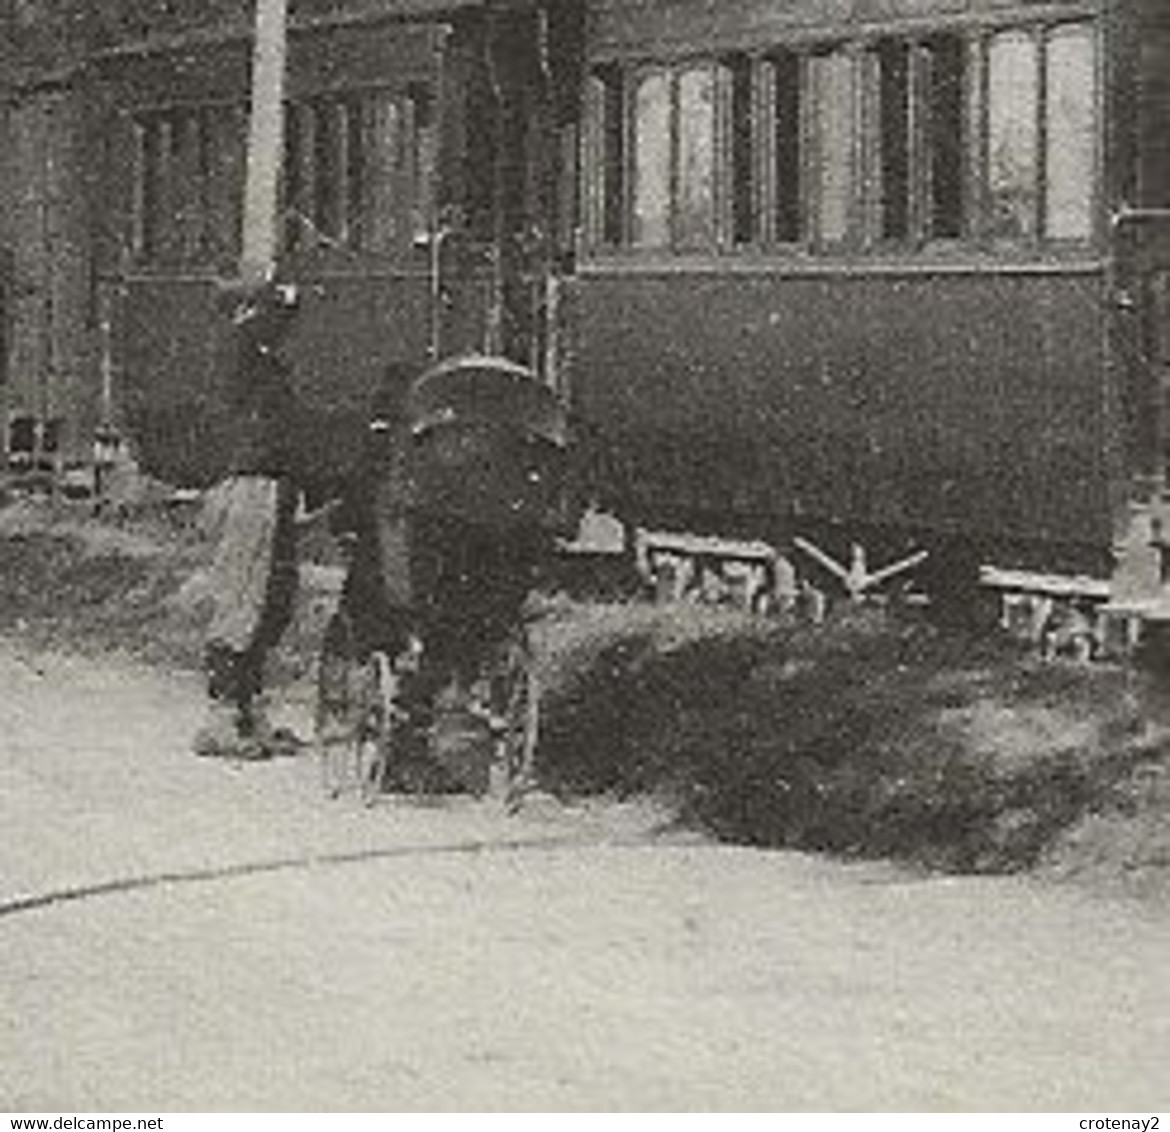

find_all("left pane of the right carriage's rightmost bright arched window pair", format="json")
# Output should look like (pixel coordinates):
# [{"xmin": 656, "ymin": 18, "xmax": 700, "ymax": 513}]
[{"xmin": 987, "ymin": 32, "xmax": 1040, "ymax": 236}]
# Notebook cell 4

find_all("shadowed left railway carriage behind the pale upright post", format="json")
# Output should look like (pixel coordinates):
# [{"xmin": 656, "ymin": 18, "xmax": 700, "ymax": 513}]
[{"xmin": 86, "ymin": 0, "xmax": 578, "ymax": 481}]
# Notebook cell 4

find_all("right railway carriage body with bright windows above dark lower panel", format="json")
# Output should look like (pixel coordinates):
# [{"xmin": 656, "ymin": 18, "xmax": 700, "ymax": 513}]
[{"xmin": 572, "ymin": 0, "xmax": 1170, "ymax": 608}]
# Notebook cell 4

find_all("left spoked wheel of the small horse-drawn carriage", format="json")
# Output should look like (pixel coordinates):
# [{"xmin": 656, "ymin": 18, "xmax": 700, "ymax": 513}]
[{"xmin": 314, "ymin": 612, "xmax": 395, "ymax": 805}]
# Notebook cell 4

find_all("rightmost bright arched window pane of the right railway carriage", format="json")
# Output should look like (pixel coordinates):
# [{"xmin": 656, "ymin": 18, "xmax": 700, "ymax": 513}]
[{"xmin": 1044, "ymin": 25, "xmax": 1097, "ymax": 240}]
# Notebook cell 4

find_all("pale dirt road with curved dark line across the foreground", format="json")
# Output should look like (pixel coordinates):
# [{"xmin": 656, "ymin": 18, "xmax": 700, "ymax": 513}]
[{"xmin": 0, "ymin": 648, "xmax": 1170, "ymax": 1112}]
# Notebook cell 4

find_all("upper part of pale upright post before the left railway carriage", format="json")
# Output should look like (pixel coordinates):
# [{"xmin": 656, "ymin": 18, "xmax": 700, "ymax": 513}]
[{"xmin": 240, "ymin": 0, "xmax": 288, "ymax": 283}]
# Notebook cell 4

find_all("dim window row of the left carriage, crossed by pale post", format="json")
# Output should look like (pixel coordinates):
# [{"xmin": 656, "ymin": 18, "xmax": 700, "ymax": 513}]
[{"xmin": 132, "ymin": 87, "xmax": 436, "ymax": 265}]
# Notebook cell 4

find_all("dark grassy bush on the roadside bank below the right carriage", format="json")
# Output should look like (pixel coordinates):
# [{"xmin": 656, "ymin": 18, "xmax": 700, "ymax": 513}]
[{"xmin": 538, "ymin": 607, "xmax": 1151, "ymax": 871}]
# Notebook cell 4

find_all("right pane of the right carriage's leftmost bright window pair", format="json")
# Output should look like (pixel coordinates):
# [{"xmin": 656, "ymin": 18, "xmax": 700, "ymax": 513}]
[{"xmin": 674, "ymin": 67, "xmax": 715, "ymax": 248}]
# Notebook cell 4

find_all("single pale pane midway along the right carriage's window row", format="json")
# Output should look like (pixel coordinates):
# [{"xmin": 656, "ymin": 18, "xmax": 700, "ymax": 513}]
[{"xmin": 811, "ymin": 50, "xmax": 855, "ymax": 243}]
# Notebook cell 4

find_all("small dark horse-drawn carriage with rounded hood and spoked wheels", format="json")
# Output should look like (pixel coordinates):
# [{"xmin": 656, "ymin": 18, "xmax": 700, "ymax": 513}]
[{"xmin": 316, "ymin": 357, "xmax": 567, "ymax": 801}]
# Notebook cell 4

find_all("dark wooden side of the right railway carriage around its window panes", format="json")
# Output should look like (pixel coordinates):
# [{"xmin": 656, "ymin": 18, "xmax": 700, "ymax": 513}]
[{"xmin": 573, "ymin": 0, "xmax": 1170, "ymax": 584}]
